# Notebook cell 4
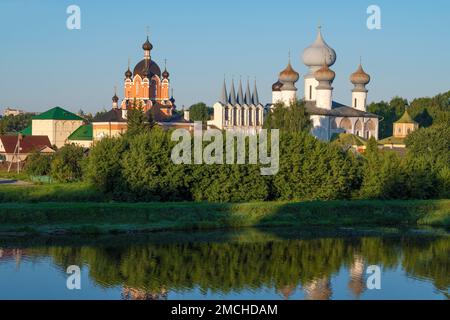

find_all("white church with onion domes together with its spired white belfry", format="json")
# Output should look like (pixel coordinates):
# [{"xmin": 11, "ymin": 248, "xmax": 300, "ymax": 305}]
[{"xmin": 208, "ymin": 27, "xmax": 379, "ymax": 141}]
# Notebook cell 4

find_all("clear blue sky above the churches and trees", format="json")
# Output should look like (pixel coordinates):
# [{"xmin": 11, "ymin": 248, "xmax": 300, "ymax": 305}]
[{"xmin": 0, "ymin": 0, "xmax": 450, "ymax": 112}]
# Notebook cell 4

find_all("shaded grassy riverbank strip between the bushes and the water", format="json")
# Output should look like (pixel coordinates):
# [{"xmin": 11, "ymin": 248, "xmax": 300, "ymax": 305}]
[{"xmin": 0, "ymin": 200, "xmax": 450, "ymax": 234}]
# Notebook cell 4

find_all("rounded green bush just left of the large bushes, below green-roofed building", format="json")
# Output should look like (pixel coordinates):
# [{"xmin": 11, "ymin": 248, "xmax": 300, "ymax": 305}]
[{"xmin": 51, "ymin": 144, "xmax": 84, "ymax": 182}]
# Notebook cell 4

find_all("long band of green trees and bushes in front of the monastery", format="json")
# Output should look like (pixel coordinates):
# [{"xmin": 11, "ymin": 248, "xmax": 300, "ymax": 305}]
[{"xmin": 27, "ymin": 95, "xmax": 450, "ymax": 202}]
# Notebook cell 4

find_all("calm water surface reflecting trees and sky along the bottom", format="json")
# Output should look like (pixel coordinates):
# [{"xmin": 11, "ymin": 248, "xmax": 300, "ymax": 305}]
[{"xmin": 0, "ymin": 229, "xmax": 450, "ymax": 300}]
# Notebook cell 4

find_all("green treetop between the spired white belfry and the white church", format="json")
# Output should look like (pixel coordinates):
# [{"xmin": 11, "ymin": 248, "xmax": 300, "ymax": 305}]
[{"xmin": 264, "ymin": 100, "xmax": 312, "ymax": 133}]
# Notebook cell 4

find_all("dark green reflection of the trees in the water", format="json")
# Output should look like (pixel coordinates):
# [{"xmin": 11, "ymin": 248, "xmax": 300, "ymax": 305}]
[{"xmin": 19, "ymin": 237, "xmax": 450, "ymax": 299}]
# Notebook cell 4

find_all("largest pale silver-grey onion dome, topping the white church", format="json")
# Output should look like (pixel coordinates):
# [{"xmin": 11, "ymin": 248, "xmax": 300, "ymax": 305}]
[{"xmin": 303, "ymin": 27, "xmax": 336, "ymax": 68}]
